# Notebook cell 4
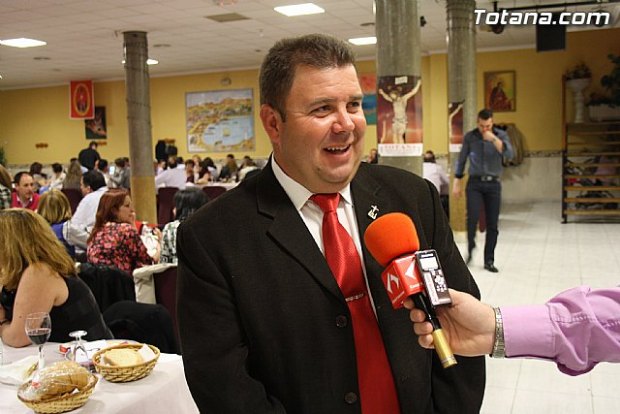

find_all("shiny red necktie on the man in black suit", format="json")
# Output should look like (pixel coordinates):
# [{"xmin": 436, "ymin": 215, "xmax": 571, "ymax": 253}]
[{"xmin": 310, "ymin": 193, "xmax": 400, "ymax": 414}]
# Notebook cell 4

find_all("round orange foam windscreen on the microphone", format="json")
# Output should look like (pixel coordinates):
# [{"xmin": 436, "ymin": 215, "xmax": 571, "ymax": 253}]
[{"xmin": 364, "ymin": 213, "xmax": 420, "ymax": 266}]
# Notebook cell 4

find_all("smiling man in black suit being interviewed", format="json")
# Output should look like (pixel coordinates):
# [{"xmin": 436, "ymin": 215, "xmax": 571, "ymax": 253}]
[{"xmin": 177, "ymin": 35, "xmax": 485, "ymax": 414}]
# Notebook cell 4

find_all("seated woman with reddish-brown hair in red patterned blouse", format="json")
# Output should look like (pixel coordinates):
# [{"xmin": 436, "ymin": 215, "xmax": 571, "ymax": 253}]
[{"xmin": 87, "ymin": 189, "xmax": 161, "ymax": 275}]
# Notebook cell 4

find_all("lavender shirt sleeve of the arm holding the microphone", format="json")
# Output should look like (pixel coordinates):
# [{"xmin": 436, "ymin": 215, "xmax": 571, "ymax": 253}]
[{"xmin": 501, "ymin": 286, "xmax": 620, "ymax": 375}]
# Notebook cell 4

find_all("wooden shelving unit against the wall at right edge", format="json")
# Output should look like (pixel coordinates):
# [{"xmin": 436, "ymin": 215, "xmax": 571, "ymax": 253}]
[{"xmin": 562, "ymin": 121, "xmax": 620, "ymax": 223}]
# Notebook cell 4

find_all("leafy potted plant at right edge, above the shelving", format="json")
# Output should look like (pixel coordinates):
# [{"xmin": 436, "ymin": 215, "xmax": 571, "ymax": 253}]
[{"xmin": 587, "ymin": 54, "xmax": 620, "ymax": 121}]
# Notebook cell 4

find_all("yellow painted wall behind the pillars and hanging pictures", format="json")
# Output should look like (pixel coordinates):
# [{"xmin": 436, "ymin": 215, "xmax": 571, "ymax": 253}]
[{"xmin": 0, "ymin": 29, "xmax": 620, "ymax": 164}]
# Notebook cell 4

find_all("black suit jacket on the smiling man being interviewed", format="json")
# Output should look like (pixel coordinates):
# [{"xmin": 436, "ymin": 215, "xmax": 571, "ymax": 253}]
[{"xmin": 177, "ymin": 163, "xmax": 485, "ymax": 414}]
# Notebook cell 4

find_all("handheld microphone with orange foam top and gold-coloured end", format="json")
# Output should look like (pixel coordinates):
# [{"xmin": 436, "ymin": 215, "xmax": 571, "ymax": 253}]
[{"xmin": 364, "ymin": 213, "xmax": 457, "ymax": 368}]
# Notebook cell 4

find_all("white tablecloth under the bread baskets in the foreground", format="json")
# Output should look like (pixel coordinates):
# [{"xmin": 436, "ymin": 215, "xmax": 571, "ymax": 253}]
[{"xmin": 0, "ymin": 343, "xmax": 198, "ymax": 414}]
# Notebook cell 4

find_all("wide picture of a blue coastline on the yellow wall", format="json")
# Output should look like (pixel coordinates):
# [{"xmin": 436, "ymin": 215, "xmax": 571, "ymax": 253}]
[{"xmin": 185, "ymin": 89, "xmax": 256, "ymax": 152}]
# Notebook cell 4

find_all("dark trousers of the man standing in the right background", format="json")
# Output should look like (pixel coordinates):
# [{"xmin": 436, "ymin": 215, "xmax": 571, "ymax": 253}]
[{"xmin": 466, "ymin": 177, "xmax": 502, "ymax": 264}]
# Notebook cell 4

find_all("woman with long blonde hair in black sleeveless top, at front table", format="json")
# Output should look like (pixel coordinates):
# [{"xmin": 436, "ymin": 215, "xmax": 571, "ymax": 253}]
[{"xmin": 0, "ymin": 208, "xmax": 113, "ymax": 347}]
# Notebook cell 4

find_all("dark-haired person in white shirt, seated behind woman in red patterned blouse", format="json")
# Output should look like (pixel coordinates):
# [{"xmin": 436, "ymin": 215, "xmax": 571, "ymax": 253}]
[{"xmin": 67, "ymin": 170, "xmax": 108, "ymax": 252}]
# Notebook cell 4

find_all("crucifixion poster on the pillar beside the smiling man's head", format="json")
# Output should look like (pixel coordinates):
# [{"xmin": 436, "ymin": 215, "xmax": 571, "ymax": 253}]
[{"xmin": 377, "ymin": 76, "xmax": 422, "ymax": 156}]
